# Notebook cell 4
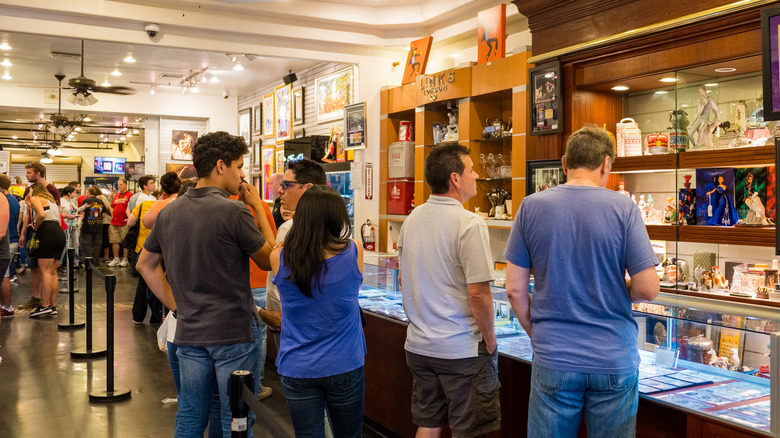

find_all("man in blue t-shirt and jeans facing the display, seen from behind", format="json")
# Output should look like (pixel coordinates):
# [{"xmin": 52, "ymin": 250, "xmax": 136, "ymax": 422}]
[{"xmin": 504, "ymin": 126, "xmax": 659, "ymax": 438}]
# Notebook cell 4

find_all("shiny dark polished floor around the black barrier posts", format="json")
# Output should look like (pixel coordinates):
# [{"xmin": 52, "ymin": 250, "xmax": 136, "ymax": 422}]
[{"xmin": 0, "ymin": 268, "xmax": 383, "ymax": 438}]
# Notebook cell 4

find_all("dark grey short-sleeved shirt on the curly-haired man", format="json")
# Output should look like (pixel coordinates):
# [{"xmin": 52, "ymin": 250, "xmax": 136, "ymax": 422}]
[{"xmin": 144, "ymin": 187, "xmax": 265, "ymax": 345}]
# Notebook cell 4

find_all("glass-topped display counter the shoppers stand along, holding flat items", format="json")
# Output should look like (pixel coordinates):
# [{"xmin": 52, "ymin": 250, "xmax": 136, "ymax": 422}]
[{"xmin": 360, "ymin": 265, "xmax": 780, "ymax": 436}]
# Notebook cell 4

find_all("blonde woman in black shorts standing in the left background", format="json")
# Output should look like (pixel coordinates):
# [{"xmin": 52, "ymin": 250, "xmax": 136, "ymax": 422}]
[{"xmin": 25, "ymin": 182, "xmax": 65, "ymax": 318}]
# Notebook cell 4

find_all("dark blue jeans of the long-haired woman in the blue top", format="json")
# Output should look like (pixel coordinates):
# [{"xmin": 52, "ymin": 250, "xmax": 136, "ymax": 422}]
[{"xmin": 279, "ymin": 367, "xmax": 365, "ymax": 438}]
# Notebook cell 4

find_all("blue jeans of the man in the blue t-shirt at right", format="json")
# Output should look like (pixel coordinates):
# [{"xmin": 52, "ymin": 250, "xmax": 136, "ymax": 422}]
[{"xmin": 528, "ymin": 359, "xmax": 639, "ymax": 438}]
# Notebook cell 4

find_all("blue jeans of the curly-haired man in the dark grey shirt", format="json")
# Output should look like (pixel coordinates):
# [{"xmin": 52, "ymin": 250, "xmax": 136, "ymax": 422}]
[{"xmin": 176, "ymin": 321, "xmax": 258, "ymax": 438}]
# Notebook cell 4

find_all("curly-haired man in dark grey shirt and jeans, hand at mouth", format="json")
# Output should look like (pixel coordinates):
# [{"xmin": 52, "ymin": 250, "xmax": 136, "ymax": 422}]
[{"xmin": 136, "ymin": 131, "xmax": 274, "ymax": 436}]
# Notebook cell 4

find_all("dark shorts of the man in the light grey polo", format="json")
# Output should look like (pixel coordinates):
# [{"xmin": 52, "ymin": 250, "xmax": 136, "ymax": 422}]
[{"xmin": 406, "ymin": 342, "xmax": 501, "ymax": 437}]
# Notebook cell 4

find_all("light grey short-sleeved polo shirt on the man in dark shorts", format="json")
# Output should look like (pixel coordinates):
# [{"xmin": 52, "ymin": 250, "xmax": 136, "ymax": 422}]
[{"xmin": 398, "ymin": 195, "xmax": 493, "ymax": 359}]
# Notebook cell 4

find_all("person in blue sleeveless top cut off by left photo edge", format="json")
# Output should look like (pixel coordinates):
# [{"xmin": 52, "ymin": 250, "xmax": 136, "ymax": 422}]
[{"xmin": 0, "ymin": 174, "xmax": 19, "ymax": 319}]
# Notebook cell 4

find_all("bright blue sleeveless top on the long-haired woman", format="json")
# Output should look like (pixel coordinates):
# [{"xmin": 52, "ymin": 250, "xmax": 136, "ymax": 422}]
[{"xmin": 273, "ymin": 241, "xmax": 366, "ymax": 378}]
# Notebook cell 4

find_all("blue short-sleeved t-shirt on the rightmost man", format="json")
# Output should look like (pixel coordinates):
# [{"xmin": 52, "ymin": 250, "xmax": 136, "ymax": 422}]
[{"xmin": 504, "ymin": 185, "xmax": 658, "ymax": 374}]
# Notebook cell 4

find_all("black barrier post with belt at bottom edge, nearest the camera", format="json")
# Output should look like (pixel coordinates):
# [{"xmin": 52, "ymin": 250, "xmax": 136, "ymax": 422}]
[{"xmin": 228, "ymin": 370, "xmax": 290, "ymax": 438}]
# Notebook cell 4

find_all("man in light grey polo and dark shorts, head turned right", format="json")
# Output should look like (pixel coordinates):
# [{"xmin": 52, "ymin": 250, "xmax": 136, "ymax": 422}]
[{"xmin": 398, "ymin": 144, "xmax": 501, "ymax": 437}]
